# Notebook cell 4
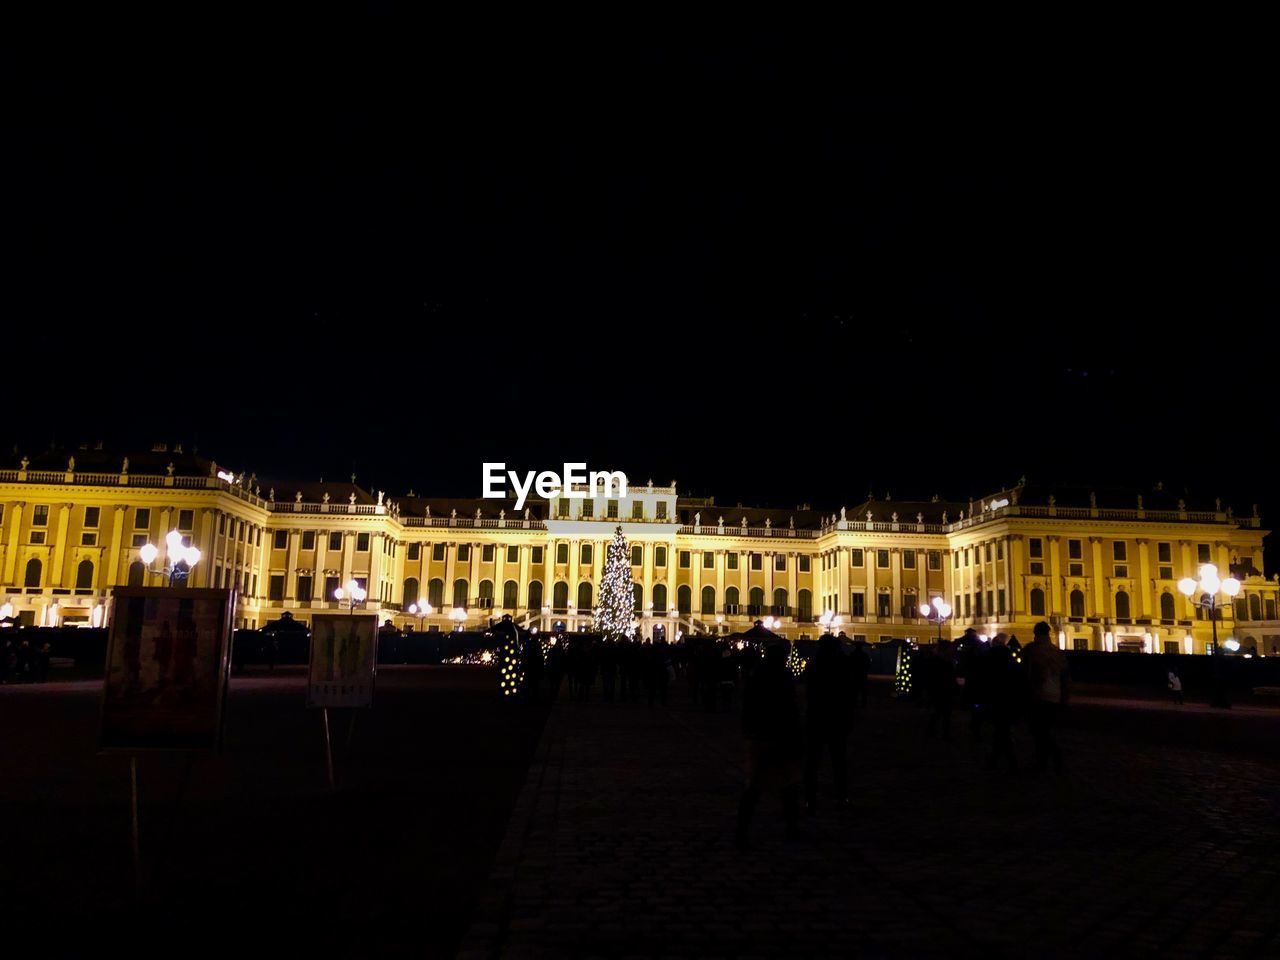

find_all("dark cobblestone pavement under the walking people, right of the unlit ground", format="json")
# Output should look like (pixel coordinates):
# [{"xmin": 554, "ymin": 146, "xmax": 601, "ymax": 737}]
[{"xmin": 461, "ymin": 689, "xmax": 1280, "ymax": 957}]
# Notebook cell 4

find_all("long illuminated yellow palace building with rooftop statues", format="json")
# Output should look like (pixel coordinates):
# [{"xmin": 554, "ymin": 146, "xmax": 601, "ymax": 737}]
[{"xmin": 0, "ymin": 447, "xmax": 1280, "ymax": 655}]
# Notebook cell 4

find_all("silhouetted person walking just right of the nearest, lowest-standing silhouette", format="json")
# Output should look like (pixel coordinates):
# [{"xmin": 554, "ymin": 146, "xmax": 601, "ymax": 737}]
[{"xmin": 804, "ymin": 634, "xmax": 855, "ymax": 812}]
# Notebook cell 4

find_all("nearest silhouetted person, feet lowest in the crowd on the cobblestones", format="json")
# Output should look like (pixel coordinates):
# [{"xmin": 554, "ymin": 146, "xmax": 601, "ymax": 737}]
[{"xmin": 735, "ymin": 644, "xmax": 803, "ymax": 846}]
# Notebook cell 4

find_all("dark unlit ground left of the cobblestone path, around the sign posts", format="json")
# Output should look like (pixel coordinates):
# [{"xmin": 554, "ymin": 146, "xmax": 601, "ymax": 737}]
[{"xmin": 0, "ymin": 667, "xmax": 545, "ymax": 956}]
